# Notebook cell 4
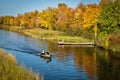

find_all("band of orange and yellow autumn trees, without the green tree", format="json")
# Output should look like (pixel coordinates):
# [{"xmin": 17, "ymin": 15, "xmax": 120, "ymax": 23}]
[{"xmin": 0, "ymin": 3, "xmax": 100, "ymax": 35}]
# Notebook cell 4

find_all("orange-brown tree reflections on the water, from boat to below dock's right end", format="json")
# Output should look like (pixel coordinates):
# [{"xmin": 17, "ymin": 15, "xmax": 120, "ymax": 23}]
[{"xmin": 49, "ymin": 44, "xmax": 96, "ymax": 80}]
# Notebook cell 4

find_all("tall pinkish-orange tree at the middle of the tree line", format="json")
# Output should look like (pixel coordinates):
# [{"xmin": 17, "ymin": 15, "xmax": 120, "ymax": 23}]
[{"xmin": 56, "ymin": 3, "xmax": 74, "ymax": 31}]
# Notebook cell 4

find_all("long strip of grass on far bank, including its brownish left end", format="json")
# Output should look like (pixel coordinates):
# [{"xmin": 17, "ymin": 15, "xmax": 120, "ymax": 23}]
[{"xmin": 1, "ymin": 25, "xmax": 93, "ymax": 42}]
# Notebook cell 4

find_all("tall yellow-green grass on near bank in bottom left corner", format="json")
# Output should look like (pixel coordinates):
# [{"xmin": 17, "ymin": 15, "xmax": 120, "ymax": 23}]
[{"xmin": 0, "ymin": 49, "xmax": 40, "ymax": 80}]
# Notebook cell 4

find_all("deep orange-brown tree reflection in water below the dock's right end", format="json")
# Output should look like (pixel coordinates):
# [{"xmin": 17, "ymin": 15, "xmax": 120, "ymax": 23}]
[{"xmin": 74, "ymin": 48, "xmax": 96, "ymax": 80}]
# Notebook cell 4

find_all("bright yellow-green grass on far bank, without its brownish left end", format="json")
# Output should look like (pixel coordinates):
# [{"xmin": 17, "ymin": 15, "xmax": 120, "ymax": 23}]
[{"xmin": 23, "ymin": 28, "xmax": 91, "ymax": 42}]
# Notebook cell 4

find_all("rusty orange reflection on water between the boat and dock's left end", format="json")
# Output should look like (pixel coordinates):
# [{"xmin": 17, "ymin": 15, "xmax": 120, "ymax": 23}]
[{"xmin": 47, "ymin": 42, "xmax": 74, "ymax": 62}]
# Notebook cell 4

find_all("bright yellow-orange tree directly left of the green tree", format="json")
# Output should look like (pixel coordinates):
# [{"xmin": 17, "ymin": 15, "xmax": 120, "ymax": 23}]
[{"xmin": 83, "ymin": 4, "xmax": 100, "ymax": 30}]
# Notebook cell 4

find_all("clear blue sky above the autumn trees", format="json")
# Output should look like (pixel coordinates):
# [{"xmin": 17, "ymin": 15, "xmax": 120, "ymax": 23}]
[{"xmin": 0, "ymin": 0, "xmax": 99, "ymax": 16}]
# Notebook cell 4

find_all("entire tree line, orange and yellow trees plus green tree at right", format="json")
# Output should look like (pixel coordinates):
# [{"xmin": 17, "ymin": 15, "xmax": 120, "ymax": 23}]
[{"xmin": 0, "ymin": 0, "xmax": 120, "ymax": 42}]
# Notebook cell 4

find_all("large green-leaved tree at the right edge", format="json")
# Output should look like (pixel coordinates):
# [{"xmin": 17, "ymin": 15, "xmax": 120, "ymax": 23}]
[{"xmin": 99, "ymin": 0, "xmax": 120, "ymax": 47}]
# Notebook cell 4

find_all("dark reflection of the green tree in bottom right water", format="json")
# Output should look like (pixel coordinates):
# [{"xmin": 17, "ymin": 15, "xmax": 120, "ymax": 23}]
[{"xmin": 97, "ymin": 49, "xmax": 120, "ymax": 80}]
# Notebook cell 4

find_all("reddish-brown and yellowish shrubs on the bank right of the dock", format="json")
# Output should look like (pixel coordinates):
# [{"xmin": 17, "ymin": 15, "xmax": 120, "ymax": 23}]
[{"xmin": 98, "ymin": 29, "xmax": 120, "ymax": 52}]
